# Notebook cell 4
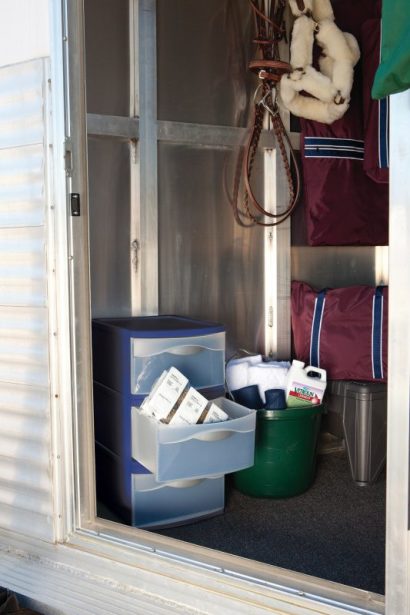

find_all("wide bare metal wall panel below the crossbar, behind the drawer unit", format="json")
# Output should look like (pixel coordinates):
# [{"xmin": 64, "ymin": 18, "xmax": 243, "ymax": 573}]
[{"xmin": 159, "ymin": 143, "xmax": 265, "ymax": 356}]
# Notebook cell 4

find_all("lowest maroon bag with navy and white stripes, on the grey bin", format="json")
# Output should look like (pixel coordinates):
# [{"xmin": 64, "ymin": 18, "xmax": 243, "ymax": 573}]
[{"xmin": 292, "ymin": 282, "xmax": 388, "ymax": 381}]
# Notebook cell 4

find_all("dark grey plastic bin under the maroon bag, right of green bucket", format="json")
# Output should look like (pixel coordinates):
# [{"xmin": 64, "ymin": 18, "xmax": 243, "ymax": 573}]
[{"xmin": 323, "ymin": 380, "xmax": 387, "ymax": 485}]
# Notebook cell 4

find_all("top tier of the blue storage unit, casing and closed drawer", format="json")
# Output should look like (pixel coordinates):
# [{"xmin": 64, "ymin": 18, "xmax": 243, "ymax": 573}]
[{"xmin": 93, "ymin": 316, "xmax": 225, "ymax": 395}]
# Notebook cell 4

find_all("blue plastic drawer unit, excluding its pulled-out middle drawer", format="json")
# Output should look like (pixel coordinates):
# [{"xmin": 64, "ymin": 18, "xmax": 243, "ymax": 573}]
[{"xmin": 93, "ymin": 316, "xmax": 225, "ymax": 527}]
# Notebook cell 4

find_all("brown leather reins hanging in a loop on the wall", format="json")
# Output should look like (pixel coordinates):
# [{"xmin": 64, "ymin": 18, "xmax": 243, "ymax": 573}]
[{"xmin": 235, "ymin": 0, "xmax": 303, "ymax": 226}]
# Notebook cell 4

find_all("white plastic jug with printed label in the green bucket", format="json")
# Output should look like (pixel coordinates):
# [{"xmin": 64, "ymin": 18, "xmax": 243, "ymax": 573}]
[{"xmin": 286, "ymin": 360, "xmax": 326, "ymax": 408}]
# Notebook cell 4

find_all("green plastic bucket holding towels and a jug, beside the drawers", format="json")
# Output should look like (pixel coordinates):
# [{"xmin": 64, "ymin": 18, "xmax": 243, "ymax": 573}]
[{"xmin": 234, "ymin": 405, "xmax": 323, "ymax": 498}]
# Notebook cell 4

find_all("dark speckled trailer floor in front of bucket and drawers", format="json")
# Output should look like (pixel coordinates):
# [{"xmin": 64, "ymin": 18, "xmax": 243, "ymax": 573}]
[{"xmin": 156, "ymin": 452, "xmax": 386, "ymax": 594}]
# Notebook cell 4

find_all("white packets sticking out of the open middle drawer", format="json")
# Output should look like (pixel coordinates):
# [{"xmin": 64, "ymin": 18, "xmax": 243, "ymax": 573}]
[{"xmin": 140, "ymin": 367, "xmax": 229, "ymax": 425}]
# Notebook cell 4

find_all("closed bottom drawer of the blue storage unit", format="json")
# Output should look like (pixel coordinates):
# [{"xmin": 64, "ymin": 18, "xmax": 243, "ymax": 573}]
[{"xmin": 131, "ymin": 474, "xmax": 225, "ymax": 527}]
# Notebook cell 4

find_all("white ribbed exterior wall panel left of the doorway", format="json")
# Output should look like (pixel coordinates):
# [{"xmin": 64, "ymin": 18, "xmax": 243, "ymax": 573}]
[{"xmin": 0, "ymin": 60, "xmax": 54, "ymax": 540}]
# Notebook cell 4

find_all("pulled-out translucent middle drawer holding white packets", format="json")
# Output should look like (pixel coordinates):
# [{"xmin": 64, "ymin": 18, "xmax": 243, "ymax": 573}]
[{"xmin": 131, "ymin": 397, "xmax": 256, "ymax": 482}]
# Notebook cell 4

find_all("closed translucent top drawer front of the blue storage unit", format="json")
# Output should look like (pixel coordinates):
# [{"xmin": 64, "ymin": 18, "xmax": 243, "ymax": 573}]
[{"xmin": 131, "ymin": 332, "xmax": 225, "ymax": 395}]
